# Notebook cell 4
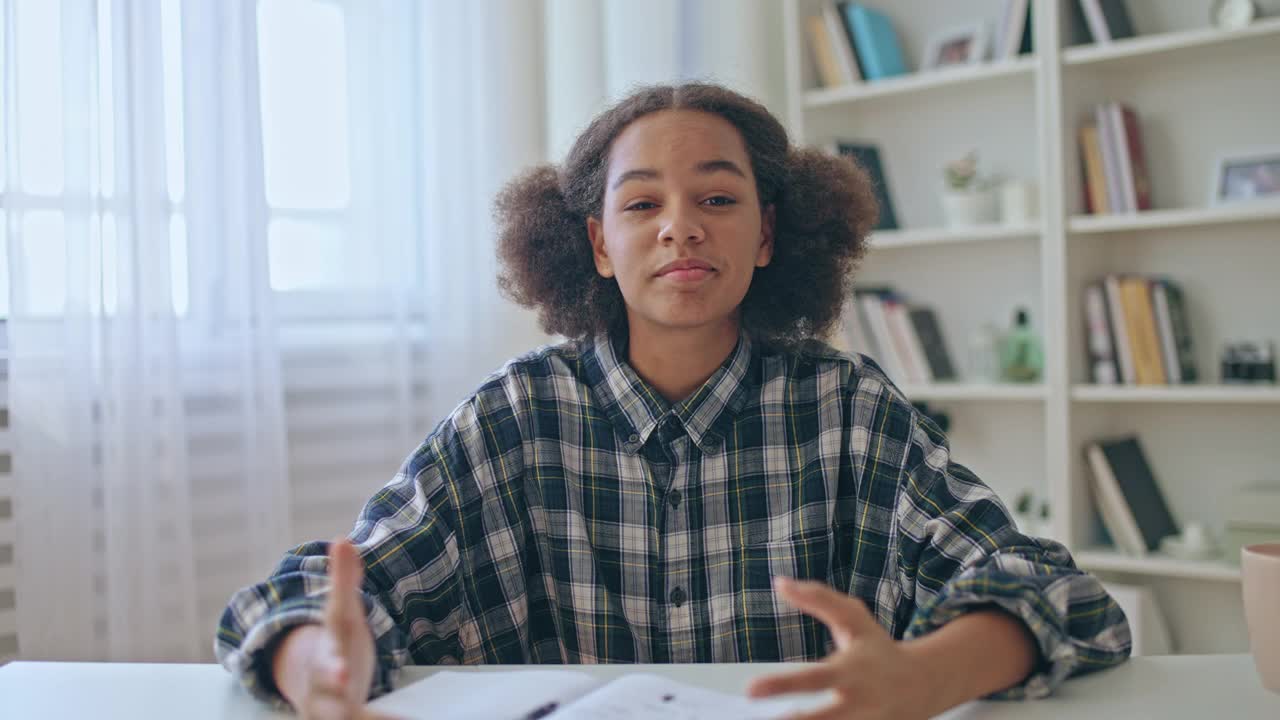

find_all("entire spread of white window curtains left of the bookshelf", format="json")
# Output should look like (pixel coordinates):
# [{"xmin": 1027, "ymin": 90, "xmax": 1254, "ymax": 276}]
[{"xmin": 0, "ymin": 0, "xmax": 781, "ymax": 660}]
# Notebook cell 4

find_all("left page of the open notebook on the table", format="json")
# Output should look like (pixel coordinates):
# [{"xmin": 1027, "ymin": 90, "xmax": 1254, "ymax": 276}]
[{"xmin": 369, "ymin": 670, "xmax": 599, "ymax": 720}]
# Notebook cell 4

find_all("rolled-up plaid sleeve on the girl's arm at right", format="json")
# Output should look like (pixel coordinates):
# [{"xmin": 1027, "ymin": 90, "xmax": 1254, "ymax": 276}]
[{"xmin": 896, "ymin": 416, "xmax": 1132, "ymax": 700}]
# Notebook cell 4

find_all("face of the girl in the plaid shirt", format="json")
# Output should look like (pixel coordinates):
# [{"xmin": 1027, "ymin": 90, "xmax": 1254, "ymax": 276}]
[{"xmin": 588, "ymin": 110, "xmax": 773, "ymax": 333}]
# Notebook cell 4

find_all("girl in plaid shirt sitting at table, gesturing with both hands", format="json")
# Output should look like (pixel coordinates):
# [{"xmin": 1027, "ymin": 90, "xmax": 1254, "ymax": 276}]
[{"xmin": 216, "ymin": 85, "xmax": 1130, "ymax": 717}]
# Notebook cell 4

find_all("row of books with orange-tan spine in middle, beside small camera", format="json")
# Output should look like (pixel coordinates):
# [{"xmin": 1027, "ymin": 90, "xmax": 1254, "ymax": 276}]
[{"xmin": 1084, "ymin": 274, "xmax": 1199, "ymax": 384}]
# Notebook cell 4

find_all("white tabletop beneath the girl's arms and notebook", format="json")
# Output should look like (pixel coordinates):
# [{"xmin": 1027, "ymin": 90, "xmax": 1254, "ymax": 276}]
[{"xmin": 0, "ymin": 655, "xmax": 1280, "ymax": 720}]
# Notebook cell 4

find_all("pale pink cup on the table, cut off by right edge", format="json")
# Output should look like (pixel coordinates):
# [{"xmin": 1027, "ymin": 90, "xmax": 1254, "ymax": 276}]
[{"xmin": 1240, "ymin": 542, "xmax": 1280, "ymax": 693}]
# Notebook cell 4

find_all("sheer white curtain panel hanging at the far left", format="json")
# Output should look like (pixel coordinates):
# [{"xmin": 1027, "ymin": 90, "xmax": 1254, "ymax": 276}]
[{"xmin": 4, "ymin": 0, "xmax": 288, "ymax": 660}]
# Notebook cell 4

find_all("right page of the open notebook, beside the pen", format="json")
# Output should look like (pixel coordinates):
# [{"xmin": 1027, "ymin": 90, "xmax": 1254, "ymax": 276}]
[{"xmin": 548, "ymin": 673, "xmax": 831, "ymax": 720}]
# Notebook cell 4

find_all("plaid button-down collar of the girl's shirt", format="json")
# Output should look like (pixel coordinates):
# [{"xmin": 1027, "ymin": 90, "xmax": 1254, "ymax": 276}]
[{"xmin": 589, "ymin": 331, "xmax": 755, "ymax": 454}]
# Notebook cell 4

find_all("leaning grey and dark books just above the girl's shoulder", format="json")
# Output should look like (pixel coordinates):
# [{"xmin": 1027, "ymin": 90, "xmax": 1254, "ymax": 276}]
[{"xmin": 845, "ymin": 287, "xmax": 956, "ymax": 384}]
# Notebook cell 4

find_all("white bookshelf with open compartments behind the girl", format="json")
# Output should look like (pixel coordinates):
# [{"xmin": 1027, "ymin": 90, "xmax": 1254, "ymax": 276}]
[{"xmin": 783, "ymin": 0, "xmax": 1280, "ymax": 652}]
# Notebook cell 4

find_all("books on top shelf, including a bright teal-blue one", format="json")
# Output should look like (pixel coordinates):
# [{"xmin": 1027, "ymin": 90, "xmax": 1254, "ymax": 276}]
[{"xmin": 805, "ymin": 3, "xmax": 906, "ymax": 87}]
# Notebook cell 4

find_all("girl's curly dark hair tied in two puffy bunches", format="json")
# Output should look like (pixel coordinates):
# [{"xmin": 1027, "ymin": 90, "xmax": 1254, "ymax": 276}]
[{"xmin": 495, "ymin": 83, "xmax": 878, "ymax": 347}]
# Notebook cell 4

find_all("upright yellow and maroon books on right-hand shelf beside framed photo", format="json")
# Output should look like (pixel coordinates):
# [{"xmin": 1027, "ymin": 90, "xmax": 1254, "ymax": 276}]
[{"xmin": 1079, "ymin": 102, "xmax": 1152, "ymax": 215}]
